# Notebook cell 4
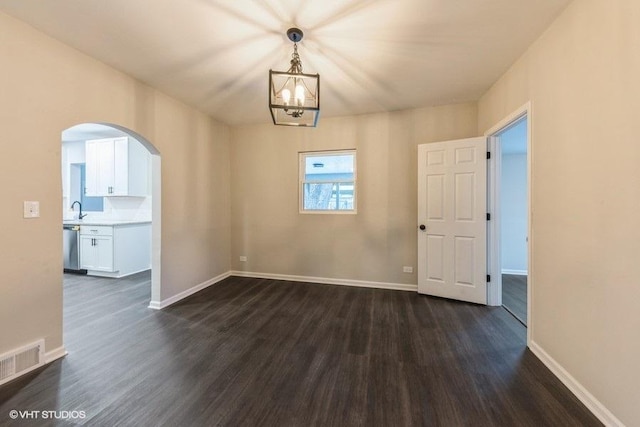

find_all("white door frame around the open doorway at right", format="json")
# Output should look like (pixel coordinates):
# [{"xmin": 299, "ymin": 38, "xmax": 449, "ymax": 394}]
[{"xmin": 484, "ymin": 101, "xmax": 534, "ymax": 345}]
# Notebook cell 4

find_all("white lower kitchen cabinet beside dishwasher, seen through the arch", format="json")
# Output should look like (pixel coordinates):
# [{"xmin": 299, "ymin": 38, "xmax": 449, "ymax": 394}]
[{"xmin": 80, "ymin": 223, "xmax": 151, "ymax": 277}]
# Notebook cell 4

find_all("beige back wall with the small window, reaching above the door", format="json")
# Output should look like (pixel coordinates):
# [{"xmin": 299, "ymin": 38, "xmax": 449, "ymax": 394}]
[{"xmin": 231, "ymin": 103, "xmax": 477, "ymax": 285}]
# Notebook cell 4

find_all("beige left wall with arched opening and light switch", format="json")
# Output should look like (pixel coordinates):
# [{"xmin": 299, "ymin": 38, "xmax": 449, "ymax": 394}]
[{"xmin": 0, "ymin": 13, "xmax": 230, "ymax": 353}]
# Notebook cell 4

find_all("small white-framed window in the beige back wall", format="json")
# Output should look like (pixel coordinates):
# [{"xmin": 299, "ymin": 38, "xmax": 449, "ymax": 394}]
[{"xmin": 300, "ymin": 150, "xmax": 356, "ymax": 213}]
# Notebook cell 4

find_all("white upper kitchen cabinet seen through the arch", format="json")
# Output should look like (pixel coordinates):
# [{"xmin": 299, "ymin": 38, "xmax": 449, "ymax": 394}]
[{"xmin": 85, "ymin": 137, "xmax": 149, "ymax": 197}]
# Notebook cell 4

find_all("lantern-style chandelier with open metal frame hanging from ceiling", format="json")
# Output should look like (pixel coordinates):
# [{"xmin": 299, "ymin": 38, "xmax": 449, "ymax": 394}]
[{"xmin": 269, "ymin": 28, "xmax": 320, "ymax": 127}]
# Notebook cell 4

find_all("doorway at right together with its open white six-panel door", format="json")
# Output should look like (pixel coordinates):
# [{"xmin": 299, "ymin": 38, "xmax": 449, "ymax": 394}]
[{"xmin": 418, "ymin": 103, "xmax": 533, "ymax": 330}]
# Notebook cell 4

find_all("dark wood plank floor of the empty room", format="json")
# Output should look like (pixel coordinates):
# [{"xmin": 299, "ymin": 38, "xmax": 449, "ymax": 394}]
[{"xmin": 0, "ymin": 274, "xmax": 601, "ymax": 427}]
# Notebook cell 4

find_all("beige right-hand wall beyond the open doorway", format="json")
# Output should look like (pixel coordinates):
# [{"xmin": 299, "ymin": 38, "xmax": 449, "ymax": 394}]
[{"xmin": 479, "ymin": 0, "xmax": 640, "ymax": 426}]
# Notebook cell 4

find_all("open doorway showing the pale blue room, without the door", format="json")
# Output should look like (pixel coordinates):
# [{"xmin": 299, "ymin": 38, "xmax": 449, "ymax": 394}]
[{"xmin": 487, "ymin": 104, "xmax": 532, "ymax": 332}]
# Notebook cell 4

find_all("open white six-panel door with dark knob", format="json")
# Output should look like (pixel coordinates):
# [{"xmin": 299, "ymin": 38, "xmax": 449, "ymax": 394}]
[{"xmin": 418, "ymin": 137, "xmax": 487, "ymax": 304}]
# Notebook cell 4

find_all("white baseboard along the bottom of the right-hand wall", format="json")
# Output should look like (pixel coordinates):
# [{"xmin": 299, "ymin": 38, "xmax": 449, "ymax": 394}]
[{"xmin": 529, "ymin": 341, "xmax": 624, "ymax": 427}]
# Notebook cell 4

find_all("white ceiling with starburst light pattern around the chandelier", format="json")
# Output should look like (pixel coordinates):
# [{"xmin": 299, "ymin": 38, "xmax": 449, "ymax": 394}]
[{"xmin": 0, "ymin": 0, "xmax": 570, "ymax": 125}]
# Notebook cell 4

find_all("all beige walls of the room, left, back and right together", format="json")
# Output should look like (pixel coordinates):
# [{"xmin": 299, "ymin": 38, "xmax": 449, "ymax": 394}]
[{"xmin": 0, "ymin": 0, "xmax": 640, "ymax": 426}]
